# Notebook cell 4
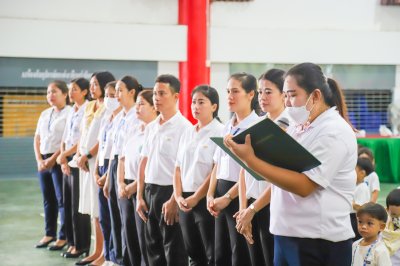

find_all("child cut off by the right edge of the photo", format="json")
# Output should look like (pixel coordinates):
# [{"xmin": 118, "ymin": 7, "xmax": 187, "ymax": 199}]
[{"xmin": 382, "ymin": 189, "xmax": 400, "ymax": 265}]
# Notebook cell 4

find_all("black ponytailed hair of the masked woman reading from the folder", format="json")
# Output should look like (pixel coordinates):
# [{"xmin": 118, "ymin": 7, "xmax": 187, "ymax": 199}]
[{"xmin": 286, "ymin": 63, "xmax": 354, "ymax": 130}]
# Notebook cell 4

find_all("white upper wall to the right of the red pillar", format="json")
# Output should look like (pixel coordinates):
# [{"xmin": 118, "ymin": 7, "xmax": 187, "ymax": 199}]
[{"xmin": 210, "ymin": 0, "xmax": 400, "ymax": 64}]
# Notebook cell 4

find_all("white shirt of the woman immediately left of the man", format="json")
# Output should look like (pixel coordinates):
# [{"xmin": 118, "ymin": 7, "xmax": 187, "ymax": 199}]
[{"xmin": 120, "ymin": 123, "xmax": 145, "ymax": 180}]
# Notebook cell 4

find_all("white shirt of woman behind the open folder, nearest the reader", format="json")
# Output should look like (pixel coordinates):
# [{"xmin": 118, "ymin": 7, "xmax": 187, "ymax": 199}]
[{"xmin": 244, "ymin": 110, "xmax": 291, "ymax": 199}]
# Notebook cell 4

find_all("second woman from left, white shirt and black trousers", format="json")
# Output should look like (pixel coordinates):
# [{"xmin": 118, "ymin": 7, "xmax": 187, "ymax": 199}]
[{"xmin": 57, "ymin": 78, "xmax": 90, "ymax": 257}]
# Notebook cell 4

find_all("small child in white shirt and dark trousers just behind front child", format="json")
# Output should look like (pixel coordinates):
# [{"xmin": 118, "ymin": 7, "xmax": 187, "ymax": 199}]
[{"xmin": 350, "ymin": 158, "xmax": 374, "ymax": 241}]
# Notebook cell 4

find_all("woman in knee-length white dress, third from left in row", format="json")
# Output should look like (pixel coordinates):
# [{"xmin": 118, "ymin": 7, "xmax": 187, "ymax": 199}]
[{"xmin": 75, "ymin": 71, "xmax": 115, "ymax": 265}]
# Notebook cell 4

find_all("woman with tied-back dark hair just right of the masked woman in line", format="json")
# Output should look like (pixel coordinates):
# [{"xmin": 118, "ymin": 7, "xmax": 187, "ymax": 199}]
[{"xmin": 103, "ymin": 76, "xmax": 143, "ymax": 265}]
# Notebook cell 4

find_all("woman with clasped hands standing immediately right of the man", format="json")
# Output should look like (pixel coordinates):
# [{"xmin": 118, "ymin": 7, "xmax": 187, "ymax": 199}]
[{"xmin": 174, "ymin": 85, "xmax": 224, "ymax": 265}]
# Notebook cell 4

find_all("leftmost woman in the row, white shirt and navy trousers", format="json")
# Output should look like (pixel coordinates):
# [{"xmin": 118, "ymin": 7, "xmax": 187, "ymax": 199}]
[{"xmin": 34, "ymin": 81, "xmax": 71, "ymax": 250}]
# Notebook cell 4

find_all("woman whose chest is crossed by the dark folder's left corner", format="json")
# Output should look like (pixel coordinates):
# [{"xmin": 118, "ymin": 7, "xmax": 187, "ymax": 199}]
[{"xmin": 207, "ymin": 73, "xmax": 260, "ymax": 265}]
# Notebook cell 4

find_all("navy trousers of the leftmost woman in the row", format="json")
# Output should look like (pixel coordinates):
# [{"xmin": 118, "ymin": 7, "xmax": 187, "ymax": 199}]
[{"xmin": 38, "ymin": 154, "xmax": 66, "ymax": 240}]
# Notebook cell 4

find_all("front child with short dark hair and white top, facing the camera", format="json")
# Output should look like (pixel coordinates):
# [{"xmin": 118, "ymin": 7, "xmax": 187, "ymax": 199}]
[{"xmin": 351, "ymin": 202, "xmax": 392, "ymax": 266}]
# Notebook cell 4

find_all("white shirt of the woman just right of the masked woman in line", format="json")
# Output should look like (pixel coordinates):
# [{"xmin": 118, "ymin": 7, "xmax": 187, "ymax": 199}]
[{"xmin": 111, "ymin": 107, "xmax": 139, "ymax": 158}]
